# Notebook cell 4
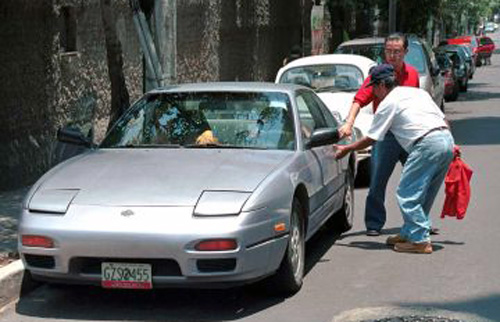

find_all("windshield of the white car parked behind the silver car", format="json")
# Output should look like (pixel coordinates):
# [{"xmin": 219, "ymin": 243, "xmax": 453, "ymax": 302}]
[{"xmin": 280, "ymin": 64, "xmax": 364, "ymax": 92}]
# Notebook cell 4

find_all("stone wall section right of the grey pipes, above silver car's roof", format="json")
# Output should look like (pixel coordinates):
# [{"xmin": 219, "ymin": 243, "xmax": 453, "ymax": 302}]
[{"xmin": 177, "ymin": 0, "xmax": 307, "ymax": 82}]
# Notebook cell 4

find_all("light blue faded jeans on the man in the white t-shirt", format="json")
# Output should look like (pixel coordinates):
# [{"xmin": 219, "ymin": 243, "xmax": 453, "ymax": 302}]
[{"xmin": 396, "ymin": 130, "xmax": 454, "ymax": 243}]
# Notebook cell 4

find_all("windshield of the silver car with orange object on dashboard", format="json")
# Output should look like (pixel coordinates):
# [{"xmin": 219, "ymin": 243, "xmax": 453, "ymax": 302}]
[{"xmin": 100, "ymin": 92, "xmax": 295, "ymax": 150}]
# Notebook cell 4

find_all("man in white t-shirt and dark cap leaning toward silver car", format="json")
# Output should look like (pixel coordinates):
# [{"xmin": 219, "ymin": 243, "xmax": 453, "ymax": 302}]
[{"xmin": 335, "ymin": 64, "xmax": 454, "ymax": 254}]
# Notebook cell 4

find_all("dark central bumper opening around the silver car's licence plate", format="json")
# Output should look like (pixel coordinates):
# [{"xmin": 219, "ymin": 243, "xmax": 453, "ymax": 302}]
[{"xmin": 70, "ymin": 257, "xmax": 182, "ymax": 276}]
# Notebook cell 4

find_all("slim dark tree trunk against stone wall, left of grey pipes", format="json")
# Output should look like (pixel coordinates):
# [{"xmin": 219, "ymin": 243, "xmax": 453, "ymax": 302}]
[{"xmin": 100, "ymin": 0, "xmax": 130, "ymax": 130}]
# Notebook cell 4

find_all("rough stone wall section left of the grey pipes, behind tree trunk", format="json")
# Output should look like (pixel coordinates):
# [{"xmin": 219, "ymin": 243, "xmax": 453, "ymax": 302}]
[{"xmin": 0, "ymin": 0, "xmax": 142, "ymax": 189}]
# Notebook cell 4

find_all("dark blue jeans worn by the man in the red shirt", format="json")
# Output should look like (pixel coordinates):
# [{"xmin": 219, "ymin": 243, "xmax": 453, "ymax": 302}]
[{"xmin": 365, "ymin": 131, "xmax": 408, "ymax": 230}]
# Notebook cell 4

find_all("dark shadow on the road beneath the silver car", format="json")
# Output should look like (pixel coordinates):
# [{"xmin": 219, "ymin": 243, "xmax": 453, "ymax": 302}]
[{"xmin": 16, "ymin": 228, "xmax": 339, "ymax": 321}]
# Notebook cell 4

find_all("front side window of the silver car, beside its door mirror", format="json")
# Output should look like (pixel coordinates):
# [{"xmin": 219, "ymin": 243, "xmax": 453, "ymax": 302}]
[{"xmin": 297, "ymin": 91, "xmax": 327, "ymax": 139}]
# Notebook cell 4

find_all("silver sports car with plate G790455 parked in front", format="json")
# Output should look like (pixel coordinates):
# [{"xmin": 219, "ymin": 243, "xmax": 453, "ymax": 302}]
[{"xmin": 19, "ymin": 83, "xmax": 355, "ymax": 293}]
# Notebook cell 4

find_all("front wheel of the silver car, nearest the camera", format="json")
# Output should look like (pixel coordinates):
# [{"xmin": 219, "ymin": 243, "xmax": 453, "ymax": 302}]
[{"xmin": 272, "ymin": 199, "xmax": 306, "ymax": 295}]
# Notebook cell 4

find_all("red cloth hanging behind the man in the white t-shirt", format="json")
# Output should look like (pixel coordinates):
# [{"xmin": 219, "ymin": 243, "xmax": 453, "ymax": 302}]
[{"xmin": 441, "ymin": 146, "xmax": 473, "ymax": 219}]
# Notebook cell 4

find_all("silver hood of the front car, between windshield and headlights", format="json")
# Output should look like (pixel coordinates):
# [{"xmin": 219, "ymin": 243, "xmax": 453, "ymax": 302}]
[{"xmin": 35, "ymin": 149, "xmax": 293, "ymax": 206}]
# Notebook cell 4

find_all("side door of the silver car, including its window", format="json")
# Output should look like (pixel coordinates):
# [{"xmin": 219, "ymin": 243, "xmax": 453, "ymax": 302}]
[{"xmin": 296, "ymin": 91, "xmax": 340, "ymax": 230}]
